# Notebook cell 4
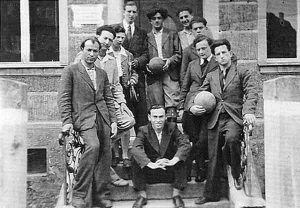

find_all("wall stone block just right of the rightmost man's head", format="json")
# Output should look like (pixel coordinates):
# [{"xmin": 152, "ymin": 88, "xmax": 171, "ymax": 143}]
[{"xmin": 220, "ymin": 31, "xmax": 258, "ymax": 60}]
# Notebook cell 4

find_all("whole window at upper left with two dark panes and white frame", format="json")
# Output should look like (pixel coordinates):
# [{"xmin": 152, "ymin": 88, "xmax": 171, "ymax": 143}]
[{"xmin": 0, "ymin": 0, "xmax": 68, "ymax": 66}]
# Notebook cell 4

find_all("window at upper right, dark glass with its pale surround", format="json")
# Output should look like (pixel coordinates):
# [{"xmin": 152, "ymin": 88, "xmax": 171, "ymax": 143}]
[{"xmin": 258, "ymin": 0, "xmax": 300, "ymax": 65}]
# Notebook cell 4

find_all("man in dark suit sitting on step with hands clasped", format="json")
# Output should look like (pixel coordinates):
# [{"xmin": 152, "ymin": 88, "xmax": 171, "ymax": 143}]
[{"xmin": 131, "ymin": 105, "xmax": 191, "ymax": 208}]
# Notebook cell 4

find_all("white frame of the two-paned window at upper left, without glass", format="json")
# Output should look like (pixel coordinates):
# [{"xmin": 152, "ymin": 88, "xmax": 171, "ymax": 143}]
[{"xmin": 0, "ymin": 0, "xmax": 69, "ymax": 68}]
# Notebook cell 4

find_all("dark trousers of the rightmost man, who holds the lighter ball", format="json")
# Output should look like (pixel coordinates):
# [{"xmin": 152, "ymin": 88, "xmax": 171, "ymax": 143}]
[{"xmin": 204, "ymin": 113, "xmax": 243, "ymax": 200}]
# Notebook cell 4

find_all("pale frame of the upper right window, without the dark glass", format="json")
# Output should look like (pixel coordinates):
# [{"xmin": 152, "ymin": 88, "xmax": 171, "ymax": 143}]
[{"xmin": 258, "ymin": 0, "xmax": 300, "ymax": 66}]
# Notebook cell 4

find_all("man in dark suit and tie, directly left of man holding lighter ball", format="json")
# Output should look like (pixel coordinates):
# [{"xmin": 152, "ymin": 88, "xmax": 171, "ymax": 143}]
[{"xmin": 179, "ymin": 35, "xmax": 218, "ymax": 182}]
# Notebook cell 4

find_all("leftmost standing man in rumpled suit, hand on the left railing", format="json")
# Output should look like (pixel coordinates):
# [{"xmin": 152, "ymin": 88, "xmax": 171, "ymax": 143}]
[{"xmin": 58, "ymin": 36, "xmax": 117, "ymax": 208}]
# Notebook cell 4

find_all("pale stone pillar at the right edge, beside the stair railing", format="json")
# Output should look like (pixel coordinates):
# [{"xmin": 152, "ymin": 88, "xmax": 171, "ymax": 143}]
[{"xmin": 264, "ymin": 76, "xmax": 300, "ymax": 207}]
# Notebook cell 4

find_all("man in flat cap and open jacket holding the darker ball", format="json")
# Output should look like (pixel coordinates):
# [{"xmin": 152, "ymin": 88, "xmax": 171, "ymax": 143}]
[{"xmin": 147, "ymin": 8, "xmax": 181, "ymax": 121}]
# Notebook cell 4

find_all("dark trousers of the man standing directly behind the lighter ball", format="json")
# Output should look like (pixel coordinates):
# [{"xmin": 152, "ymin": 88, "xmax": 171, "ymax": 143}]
[{"xmin": 182, "ymin": 111, "xmax": 208, "ymax": 177}]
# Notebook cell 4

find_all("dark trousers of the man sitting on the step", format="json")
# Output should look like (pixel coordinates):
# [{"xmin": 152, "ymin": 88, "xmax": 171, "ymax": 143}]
[{"xmin": 132, "ymin": 160, "xmax": 187, "ymax": 191}]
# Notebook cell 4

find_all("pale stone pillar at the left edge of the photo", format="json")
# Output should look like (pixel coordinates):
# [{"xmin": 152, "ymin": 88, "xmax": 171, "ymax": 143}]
[{"xmin": 0, "ymin": 79, "xmax": 27, "ymax": 208}]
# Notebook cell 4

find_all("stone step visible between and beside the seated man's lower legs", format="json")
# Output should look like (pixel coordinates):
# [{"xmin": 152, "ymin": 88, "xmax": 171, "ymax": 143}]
[{"xmin": 111, "ymin": 180, "xmax": 205, "ymax": 201}]
